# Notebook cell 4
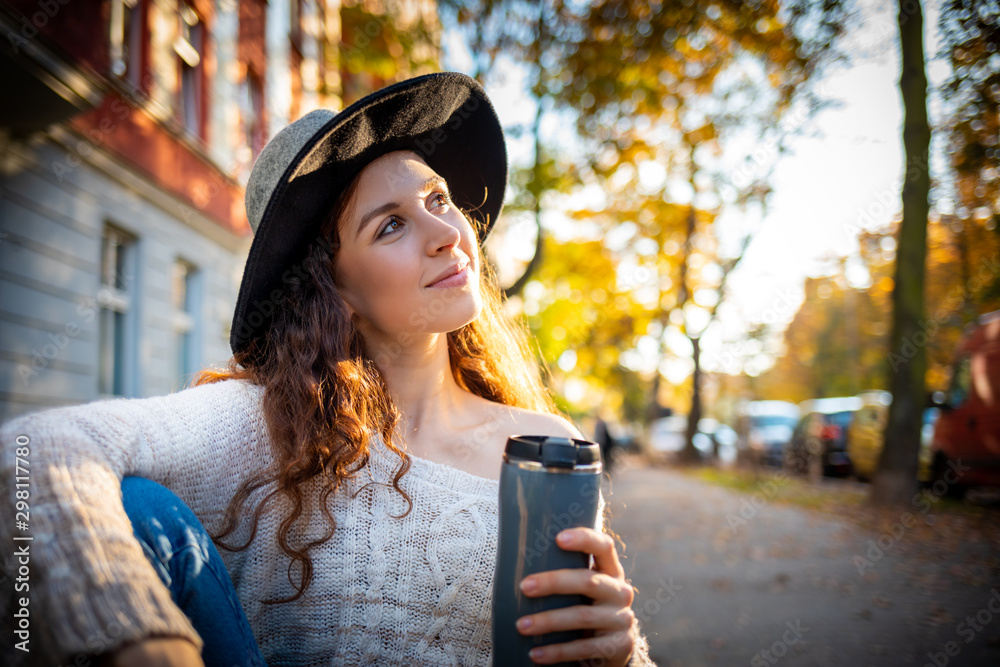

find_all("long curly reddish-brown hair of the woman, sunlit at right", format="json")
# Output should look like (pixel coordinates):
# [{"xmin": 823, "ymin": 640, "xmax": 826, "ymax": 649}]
[{"xmin": 194, "ymin": 174, "xmax": 561, "ymax": 604}]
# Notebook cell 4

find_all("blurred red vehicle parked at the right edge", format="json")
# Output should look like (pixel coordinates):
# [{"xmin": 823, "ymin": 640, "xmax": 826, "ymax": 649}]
[{"xmin": 932, "ymin": 310, "xmax": 1000, "ymax": 493}]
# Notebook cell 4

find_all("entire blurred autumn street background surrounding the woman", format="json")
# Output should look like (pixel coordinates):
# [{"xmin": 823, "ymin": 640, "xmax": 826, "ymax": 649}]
[{"xmin": 0, "ymin": 0, "xmax": 1000, "ymax": 665}]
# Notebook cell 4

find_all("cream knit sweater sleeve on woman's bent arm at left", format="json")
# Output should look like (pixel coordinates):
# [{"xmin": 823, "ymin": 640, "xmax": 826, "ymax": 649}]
[{"xmin": 0, "ymin": 382, "xmax": 266, "ymax": 664}]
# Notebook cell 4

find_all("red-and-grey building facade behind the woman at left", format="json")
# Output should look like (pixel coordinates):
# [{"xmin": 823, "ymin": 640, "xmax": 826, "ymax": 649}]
[{"xmin": 0, "ymin": 0, "xmax": 438, "ymax": 421}]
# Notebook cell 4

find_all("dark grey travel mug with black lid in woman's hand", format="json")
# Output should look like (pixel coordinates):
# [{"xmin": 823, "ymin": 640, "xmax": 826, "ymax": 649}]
[{"xmin": 493, "ymin": 435, "xmax": 601, "ymax": 667}]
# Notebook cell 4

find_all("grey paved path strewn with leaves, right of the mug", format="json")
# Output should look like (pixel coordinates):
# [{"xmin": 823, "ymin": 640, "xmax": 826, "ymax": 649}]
[{"xmin": 605, "ymin": 466, "xmax": 1000, "ymax": 667}]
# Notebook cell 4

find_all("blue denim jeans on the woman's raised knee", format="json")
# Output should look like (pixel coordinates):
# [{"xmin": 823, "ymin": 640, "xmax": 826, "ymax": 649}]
[{"xmin": 122, "ymin": 477, "xmax": 267, "ymax": 667}]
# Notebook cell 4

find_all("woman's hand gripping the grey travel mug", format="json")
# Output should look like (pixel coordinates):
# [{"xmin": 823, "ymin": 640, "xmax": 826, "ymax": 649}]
[{"xmin": 517, "ymin": 528, "xmax": 636, "ymax": 667}]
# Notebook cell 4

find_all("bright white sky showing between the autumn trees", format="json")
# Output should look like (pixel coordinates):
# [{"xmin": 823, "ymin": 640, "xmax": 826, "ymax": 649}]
[{"xmin": 445, "ymin": 0, "xmax": 947, "ymax": 382}]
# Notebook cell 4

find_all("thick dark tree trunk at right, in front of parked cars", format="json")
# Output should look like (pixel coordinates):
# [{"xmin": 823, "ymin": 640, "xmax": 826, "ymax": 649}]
[{"xmin": 871, "ymin": 0, "xmax": 931, "ymax": 505}]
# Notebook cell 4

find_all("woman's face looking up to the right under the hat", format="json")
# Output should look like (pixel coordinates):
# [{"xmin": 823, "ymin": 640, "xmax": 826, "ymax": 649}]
[{"xmin": 336, "ymin": 151, "xmax": 482, "ymax": 345}]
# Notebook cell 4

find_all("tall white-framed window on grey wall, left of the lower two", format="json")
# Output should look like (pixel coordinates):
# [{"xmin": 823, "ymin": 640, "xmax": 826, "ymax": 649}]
[{"xmin": 97, "ymin": 225, "xmax": 136, "ymax": 396}]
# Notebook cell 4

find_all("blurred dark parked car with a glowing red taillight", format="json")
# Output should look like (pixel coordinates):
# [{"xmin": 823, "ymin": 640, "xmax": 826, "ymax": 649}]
[{"xmin": 785, "ymin": 396, "xmax": 861, "ymax": 477}]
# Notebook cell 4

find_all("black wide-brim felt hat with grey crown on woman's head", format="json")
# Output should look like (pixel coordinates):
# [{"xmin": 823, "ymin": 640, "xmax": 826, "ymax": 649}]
[{"xmin": 229, "ymin": 72, "xmax": 507, "ymax": 353}]
